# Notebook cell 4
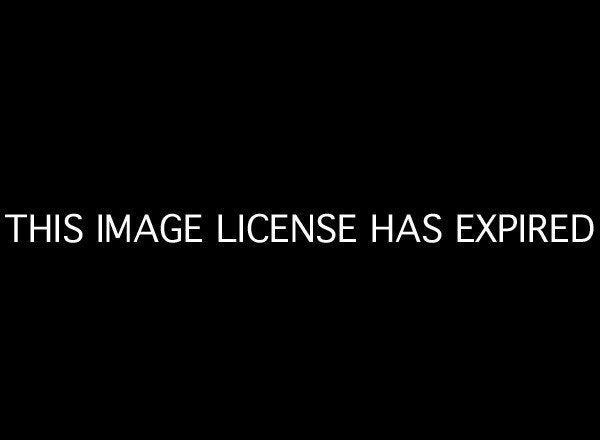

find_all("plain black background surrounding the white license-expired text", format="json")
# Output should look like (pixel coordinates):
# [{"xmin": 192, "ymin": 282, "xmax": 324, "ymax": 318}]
[{"xmin": 1, "ymin": 5, "xmax": 598, "ymax": 433}]
